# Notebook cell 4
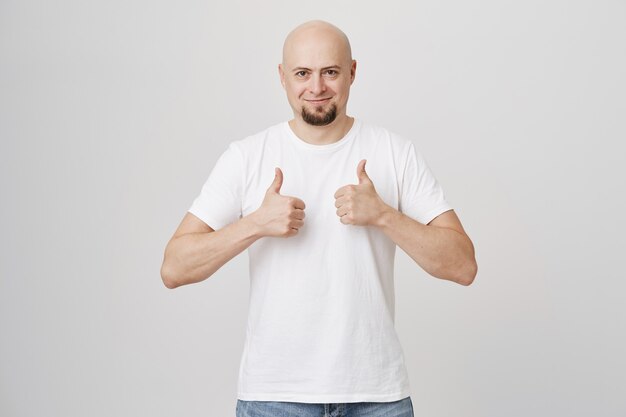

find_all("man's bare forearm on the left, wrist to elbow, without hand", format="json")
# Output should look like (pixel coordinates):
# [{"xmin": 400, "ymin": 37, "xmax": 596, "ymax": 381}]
[{"xmin": 161, "ymin": 217, "xmax": 261, "ymax": 288}]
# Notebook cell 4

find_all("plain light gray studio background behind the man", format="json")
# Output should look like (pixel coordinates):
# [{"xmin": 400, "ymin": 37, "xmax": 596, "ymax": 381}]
[{"xmin": 0, "ymin": 0, "xmax": 626, "ymax": 417}]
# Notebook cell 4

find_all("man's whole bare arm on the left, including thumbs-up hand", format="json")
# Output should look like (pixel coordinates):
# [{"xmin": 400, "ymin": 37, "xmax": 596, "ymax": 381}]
[{"xmin": 161, "ymin": 168, "xmax": 305, "ymax": 289}]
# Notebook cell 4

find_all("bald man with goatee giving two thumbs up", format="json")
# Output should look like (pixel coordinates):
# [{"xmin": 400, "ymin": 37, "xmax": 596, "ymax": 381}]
[{"xmin": 161, "ymin": 21, "xmax": 477, "ymax": 417}]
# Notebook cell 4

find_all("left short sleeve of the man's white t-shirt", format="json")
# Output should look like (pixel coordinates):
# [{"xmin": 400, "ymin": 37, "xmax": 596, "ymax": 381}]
[{"xmin": 188, "ymin": 143, "xmax": 243, "ymax": 230}]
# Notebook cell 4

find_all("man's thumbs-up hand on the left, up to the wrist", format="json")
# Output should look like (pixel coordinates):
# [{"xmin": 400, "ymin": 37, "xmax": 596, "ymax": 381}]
[{"xmin": 252, "ymin": 168, "xmax": 304, "ymax": 237}]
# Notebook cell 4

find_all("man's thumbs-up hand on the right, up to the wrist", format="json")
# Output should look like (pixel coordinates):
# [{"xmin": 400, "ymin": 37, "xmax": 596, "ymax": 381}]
[{"xmin": 335, "ymin": 159, "xmax": 389, "ymax": 226}]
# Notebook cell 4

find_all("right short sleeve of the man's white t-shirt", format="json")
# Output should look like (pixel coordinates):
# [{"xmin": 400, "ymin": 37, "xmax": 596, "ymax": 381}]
[{"xmin": 399, "ymin": 143, "xmax": 452, "ymax": 224}]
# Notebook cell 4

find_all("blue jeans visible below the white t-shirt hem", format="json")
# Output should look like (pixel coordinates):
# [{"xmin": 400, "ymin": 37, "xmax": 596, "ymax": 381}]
[{"xmin": 236, "ymin": 396, "xmax": 414, "ymax": 417}]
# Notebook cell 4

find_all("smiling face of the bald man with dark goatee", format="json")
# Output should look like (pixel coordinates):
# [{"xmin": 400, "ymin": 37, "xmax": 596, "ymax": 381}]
[{"xmin": 278, "ymin": 30, "xmax": 356, "ymax": 126}]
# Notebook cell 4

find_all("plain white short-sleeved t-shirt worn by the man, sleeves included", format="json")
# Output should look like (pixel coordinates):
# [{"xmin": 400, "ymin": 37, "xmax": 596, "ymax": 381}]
[{"xmin": 189, "ymin": 119, "xmax": 452, "ymax": 403}]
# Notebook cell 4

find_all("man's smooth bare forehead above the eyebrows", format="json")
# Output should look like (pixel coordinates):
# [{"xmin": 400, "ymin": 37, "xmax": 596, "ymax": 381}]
[{"xmin": 283, "ymin": 29, "xmax": 350, "ymax": 68}]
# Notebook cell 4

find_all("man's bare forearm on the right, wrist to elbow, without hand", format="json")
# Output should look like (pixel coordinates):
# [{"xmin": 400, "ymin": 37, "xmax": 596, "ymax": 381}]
[{"xmin": 379, "ymin": 207, "xmax": 477, "ymax": 285}]
